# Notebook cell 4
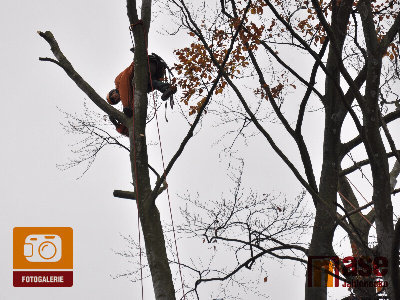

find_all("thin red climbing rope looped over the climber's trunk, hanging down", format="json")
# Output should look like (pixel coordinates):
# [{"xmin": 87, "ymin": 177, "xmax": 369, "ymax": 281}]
[{"xmin": 129, "ymin": 20, "xmax": 186, "ymax": 299}]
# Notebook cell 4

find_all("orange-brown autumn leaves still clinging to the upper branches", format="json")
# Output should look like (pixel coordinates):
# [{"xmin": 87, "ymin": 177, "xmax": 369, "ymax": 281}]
[{"xmin": 170, "ymin": 0, "xmax": 400, "ymax": 115}]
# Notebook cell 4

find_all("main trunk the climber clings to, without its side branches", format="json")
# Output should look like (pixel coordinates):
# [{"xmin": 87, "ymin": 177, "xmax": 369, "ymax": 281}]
[{"xmin": 127, "ymin": 0, "xmax": 176, "ymax": 300}]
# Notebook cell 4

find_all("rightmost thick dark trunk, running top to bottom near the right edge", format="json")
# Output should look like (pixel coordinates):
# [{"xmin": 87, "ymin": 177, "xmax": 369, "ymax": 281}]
[{"xmin": 357, "ymin": 0, "xmax": 394, "ymax": 292}]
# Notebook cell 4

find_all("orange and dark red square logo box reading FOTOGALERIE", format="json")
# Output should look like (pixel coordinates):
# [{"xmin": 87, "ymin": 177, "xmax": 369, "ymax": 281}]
[{"xmin": 13, "ymin": 227, "xmax": 73, "ymax": 287}]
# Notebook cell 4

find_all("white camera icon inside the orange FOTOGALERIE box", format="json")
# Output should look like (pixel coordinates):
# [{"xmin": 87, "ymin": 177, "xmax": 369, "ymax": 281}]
[{"xmin": 24, "ymin": 234, "xmax": 61, "ymax": 262}]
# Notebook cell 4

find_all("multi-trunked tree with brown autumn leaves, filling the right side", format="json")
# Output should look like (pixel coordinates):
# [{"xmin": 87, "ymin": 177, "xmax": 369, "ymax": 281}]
[{"xmin": 173, "ymin": 0, "xmax": 400, "ymax": 299}]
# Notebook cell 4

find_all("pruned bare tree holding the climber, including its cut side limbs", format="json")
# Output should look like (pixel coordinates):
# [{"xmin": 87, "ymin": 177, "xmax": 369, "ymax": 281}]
[{"xmin": 38, "ymin": 0, "xmax": 178, "ymax": 300}]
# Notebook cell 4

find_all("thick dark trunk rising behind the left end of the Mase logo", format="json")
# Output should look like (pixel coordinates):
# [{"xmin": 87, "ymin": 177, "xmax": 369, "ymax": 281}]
[{"xmin": 305, "ymin": 1, "xmax": 352, "ymax": 300}]
